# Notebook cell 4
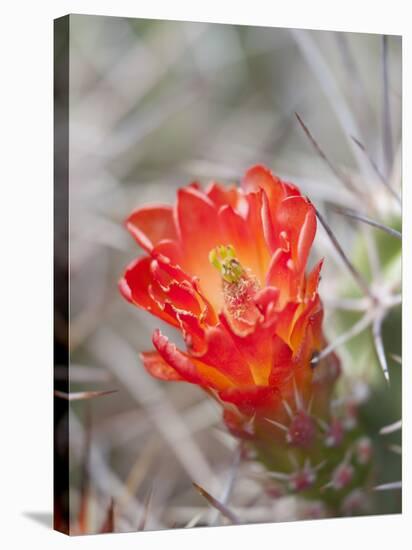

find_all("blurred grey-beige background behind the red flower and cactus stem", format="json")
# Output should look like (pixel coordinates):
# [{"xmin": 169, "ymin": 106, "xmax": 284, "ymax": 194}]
[{"xmin": 56, "ymin": 15, "xmax": 402, "ymax": 532}]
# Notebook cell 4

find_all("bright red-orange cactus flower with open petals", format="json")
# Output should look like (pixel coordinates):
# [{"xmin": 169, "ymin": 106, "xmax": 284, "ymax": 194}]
[{"xmin": 119, "ymin": 166, "xmax": 323, "ymax": 431}]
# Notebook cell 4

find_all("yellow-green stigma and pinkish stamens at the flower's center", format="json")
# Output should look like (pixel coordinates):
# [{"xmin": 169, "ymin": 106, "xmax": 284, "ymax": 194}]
[{"xmin": 209, "ymin": 245, "xmax": 259, "ymax": 328}]
